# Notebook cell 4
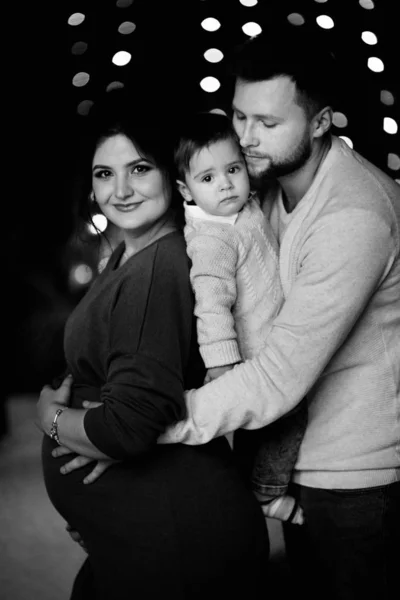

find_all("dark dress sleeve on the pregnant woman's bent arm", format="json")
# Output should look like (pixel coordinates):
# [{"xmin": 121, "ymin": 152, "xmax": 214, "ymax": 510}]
[{"xmin": 84, "ymin": 243, "xmax": 193, "ymax": 459}]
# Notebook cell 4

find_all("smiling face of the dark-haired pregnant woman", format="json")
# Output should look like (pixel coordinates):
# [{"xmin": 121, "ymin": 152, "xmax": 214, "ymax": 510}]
[{"xmin": 92, "ymin": 134, "xmax": 171, "ymax": 235}]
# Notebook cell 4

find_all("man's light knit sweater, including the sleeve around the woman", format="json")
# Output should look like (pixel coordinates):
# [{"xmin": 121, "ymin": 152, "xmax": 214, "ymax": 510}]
[{"xmin": 161, "ymin": 137, "xmax": 400, "ymax": 489}]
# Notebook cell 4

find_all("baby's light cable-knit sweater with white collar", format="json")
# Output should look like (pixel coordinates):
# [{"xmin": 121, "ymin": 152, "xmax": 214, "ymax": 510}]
[{"xmin": 184, "ymin": 199, "xmax": 283, "ymax": 368}]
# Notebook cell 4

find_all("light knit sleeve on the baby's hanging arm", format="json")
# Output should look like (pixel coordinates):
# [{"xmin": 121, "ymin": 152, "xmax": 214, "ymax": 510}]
[{"xmin": 186, "ymin": 230, "xmax": 241, "ymax": 368}]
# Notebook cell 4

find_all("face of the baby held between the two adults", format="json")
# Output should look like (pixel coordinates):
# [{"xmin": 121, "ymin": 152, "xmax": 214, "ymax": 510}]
[{"xmin": 186, "ymin": 139, "xmax": 250, "ymax": 217}]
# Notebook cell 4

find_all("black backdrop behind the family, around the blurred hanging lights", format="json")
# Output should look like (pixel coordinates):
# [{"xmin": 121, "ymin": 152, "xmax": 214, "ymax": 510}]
[{"xmin": 0, "ymin": 0, "xmax": 400, "ymax": 430}]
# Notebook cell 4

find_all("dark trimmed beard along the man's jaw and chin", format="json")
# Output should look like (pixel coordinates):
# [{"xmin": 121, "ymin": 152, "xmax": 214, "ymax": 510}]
[{"xmin": 247, "ymin": 135, "xmax": 312, "ymax": 189}]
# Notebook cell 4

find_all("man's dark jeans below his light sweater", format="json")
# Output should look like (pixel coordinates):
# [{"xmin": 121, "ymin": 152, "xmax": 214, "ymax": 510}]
[{"xmin": 284, "ymin": 482, "xmax": 400, "ymax": 600}]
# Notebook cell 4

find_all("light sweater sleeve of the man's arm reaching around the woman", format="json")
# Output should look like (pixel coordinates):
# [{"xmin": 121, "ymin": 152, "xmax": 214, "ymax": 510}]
[{"xmin": 160, "ymin": 209, "xmax": 397, "ymax": 444}]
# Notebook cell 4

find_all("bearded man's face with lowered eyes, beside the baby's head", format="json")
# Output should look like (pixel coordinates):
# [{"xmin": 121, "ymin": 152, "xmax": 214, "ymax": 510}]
[{"xmin": 233, "ymin": 76, "xmax": 312, "ymax": 184}]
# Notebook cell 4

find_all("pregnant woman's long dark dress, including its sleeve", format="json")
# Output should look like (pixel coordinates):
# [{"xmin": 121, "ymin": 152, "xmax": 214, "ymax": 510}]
[{"xmin": 43, "ymin": 232, "xmax": 268, "ymax": 600}]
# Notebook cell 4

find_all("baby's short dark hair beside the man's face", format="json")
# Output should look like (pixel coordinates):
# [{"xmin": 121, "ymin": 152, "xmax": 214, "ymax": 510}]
[{"xmin": 174, "ymin": 112, "xmax": 239, "ymax": 180}]
